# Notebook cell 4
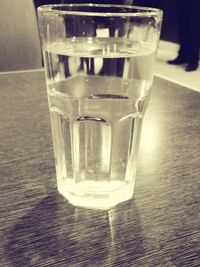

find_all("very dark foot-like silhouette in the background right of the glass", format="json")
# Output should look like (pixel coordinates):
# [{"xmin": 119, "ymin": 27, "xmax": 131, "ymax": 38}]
[{"xmin": 134, "ymin": 0, "xmax": 200, "ymax": 71}]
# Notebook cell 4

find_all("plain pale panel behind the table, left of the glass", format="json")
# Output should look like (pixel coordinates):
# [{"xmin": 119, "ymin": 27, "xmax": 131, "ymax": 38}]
[{"xmin": 0, "ymin": 0, "xmax": 42, "ymax": 71}]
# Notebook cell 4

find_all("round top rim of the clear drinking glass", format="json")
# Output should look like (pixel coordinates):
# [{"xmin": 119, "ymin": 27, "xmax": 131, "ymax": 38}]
[{"xmin": 37, "ymin": 3, "xmax": 163, "ymax": 17}]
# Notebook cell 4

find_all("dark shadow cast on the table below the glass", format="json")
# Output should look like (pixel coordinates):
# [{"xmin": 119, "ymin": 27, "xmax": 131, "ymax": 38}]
[{"xmin": 5, "ymin": 194, "xmax": 143, "ymax": 267}]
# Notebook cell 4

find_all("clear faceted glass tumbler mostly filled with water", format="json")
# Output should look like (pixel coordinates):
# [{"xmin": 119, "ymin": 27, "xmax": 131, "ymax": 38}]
[{"xmin": 38, "ymin": 4, "xmax": 162, "ymax": 209}]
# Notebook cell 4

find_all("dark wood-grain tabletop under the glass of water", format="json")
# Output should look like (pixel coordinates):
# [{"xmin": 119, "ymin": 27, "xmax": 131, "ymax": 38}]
[{"xmin": 0, "ymin": 71, "xmax": 200, "ymax": 267}]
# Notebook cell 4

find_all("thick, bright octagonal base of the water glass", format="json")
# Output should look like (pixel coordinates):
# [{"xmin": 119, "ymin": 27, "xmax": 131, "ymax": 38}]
[{"xmin": 58, "ymin": 179, "xmax": 134, "ymax": 210}]
